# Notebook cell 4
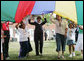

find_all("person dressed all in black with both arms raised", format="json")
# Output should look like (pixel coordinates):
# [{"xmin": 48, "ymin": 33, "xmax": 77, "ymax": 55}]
[{"xmin": 29, "ymin": 16, "xmax": 47, "ymax": 56}]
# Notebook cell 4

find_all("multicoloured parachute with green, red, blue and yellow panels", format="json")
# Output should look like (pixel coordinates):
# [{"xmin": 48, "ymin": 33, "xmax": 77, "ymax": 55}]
[{"xmin": 1, "ymin": 1, "xmax": 83, "ymax": 25}]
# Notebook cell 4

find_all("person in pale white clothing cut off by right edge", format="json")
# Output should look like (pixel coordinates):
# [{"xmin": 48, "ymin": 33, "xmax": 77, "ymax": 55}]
[{"xmin": 75, "ymin": 26, "xmax": 83, "ymax": 56}]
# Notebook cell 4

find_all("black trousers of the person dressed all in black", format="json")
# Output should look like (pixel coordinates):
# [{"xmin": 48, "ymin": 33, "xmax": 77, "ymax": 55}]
[{"xmin": 34, "ymin": 33, "xmax": 43, "ymax": 55}]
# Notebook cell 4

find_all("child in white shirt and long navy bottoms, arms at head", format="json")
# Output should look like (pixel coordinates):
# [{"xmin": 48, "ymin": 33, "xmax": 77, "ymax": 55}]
[{"xmin": 16, "ymin": 21, "xmax": 30, "ymax": 58}]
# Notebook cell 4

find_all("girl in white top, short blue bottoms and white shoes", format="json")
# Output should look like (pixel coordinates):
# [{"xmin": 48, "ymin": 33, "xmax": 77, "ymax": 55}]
[{"xmin": 67, "ymin": 23, "xmax": 76, "ymax": 57}]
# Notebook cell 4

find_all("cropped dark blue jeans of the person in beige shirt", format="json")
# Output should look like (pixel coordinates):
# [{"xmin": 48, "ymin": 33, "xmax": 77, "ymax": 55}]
[{"xmin": 56, "ymin": 33, "xmax": 66, "ymax": 52}]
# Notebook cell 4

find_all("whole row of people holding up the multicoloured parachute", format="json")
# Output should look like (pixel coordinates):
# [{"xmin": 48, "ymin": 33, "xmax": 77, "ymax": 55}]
[{"xmin": 1, "ymin": 14, "xmax": 83, "ymax": 60}]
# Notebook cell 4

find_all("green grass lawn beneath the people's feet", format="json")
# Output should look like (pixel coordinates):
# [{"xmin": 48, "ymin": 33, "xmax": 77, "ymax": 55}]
[{"xmin": 8, "ymin": 40, "xmax": 83, "ymax": 60}]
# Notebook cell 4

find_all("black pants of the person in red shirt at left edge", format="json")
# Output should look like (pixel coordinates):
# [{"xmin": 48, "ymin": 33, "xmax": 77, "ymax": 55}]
[{"xmin": 3, "ymin": 31, "xmax": 10, "ymax": 59}]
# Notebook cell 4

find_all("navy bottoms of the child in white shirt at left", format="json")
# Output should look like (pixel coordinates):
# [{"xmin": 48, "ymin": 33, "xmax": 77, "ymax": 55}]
[{"xmin": 19, "ymin": 41, "xmax": 29, "ymax": 58}]
